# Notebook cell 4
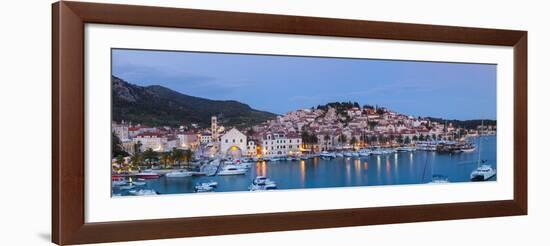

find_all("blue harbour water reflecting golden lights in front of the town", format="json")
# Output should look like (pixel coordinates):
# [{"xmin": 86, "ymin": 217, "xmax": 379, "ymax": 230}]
[{"xmin": 115, "ymin": 136, "xmax": 498, "ymax": 194}]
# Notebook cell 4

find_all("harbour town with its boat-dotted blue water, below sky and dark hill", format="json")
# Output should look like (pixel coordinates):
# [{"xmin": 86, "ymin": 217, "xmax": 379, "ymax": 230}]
[{"xmin": 111, "ymin": 102, "xmax": 497, "ymax": 196}]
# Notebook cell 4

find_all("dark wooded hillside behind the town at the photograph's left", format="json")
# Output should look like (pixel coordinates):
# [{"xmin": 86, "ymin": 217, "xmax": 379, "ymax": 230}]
[{"xmin": 111, "ymin": 76, "xmax": 276, "ymax": 127}]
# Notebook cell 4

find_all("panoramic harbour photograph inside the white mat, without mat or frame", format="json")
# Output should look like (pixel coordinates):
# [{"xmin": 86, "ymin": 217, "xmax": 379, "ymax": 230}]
[{"xmin": 110, "ymin": 48, "xmax": 497, "ymax": 197}]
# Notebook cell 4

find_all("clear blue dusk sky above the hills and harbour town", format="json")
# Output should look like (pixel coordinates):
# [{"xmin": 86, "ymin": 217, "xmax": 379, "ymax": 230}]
[{"xmin": 112, "ymin": 49, "xmax": 496, "ymax": 120}]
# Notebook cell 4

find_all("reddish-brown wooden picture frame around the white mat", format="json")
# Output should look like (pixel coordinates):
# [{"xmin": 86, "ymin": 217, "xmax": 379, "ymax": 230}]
[{"xmin": 52, "ymin": 1, "xmax": 527, "ymax": 245}]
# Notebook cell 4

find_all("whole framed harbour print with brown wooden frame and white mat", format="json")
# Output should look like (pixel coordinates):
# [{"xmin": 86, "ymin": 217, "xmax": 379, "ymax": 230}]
[{"xmin": 52, "ymin": 1, "xmax": 527, "ymax": 245}]
